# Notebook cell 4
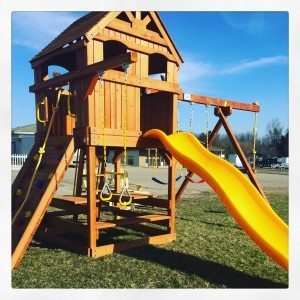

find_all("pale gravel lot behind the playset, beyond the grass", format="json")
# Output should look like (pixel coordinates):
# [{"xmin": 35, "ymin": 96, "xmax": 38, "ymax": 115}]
[{"xmin": 12, "ymin": 164, "xmax": 288, "ymax": 195}]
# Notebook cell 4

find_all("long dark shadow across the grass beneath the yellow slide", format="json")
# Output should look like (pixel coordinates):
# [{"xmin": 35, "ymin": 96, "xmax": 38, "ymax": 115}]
[{"xmin": 122, "ymin": 246, "xmax": 288, "ymax": 288}]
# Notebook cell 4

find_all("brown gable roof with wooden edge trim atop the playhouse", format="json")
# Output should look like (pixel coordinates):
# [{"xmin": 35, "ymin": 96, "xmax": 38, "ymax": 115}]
[{"xmin": 31, "ymin": 12, "xmax": 183, "ymax": 65}]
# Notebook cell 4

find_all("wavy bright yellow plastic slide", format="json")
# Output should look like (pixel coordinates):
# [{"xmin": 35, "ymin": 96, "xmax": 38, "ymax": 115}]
[{"xmin": 144, "ymin": 129, "xmax": 288, "ymax": 270}]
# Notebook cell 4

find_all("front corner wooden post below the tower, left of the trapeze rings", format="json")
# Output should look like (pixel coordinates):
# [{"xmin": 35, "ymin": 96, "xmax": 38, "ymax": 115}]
[{"xmin": 86, "ymin": 146, "xmax": 97, "ymax": 251}]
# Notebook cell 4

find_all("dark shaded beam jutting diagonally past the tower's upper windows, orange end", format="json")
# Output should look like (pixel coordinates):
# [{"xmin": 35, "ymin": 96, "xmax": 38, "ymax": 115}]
[{"xmin": 29, "ymin": 52, "xmax": 138, "ymax": 93}]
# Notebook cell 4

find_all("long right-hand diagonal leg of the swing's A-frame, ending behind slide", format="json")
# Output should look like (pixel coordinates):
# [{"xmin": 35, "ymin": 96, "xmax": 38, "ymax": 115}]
[{"xmin": 215, "ymin": 107, "xmax": 267, "ymax": 201}]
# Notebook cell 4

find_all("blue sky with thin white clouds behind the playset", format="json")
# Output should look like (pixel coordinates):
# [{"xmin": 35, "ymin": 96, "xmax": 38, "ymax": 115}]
[{"xmin": 12, "ymin": 12, "xmax": 289, "ymax": 136}]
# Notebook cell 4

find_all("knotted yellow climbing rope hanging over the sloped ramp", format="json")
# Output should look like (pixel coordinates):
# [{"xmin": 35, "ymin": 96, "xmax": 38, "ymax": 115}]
[{"xmin": 12, "ymin": 89, "xmax": 62, "ymax": 224}]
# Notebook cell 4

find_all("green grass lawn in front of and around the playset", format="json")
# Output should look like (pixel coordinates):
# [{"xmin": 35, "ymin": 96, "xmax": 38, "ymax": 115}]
[{"xmin": 12, "ymin": 192, "xmax": 288, "ymax": 288}]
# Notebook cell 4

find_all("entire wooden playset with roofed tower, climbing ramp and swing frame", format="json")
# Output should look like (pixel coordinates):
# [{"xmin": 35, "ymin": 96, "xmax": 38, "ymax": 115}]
[{"xmin": 12, "ymin": 12, "xmax": 263, "ymax": 268}]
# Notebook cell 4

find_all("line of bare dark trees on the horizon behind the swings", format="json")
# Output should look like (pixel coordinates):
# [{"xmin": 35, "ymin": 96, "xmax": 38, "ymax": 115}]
[{"xmin": 196, "ymin": 118, "xmax": 289, "ymax": 157}]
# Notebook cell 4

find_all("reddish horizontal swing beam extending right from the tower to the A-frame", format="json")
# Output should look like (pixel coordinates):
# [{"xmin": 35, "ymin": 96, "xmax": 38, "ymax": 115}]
[{"xmin": 178, "ymin": 92, "xmax": 260, "ymax": 112}]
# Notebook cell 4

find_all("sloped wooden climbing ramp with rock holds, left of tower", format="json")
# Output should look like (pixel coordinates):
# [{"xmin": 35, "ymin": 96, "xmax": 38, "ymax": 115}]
[{"xmin": 12, "ymin": 136, "xmax": 74, "ymax": 268}]
